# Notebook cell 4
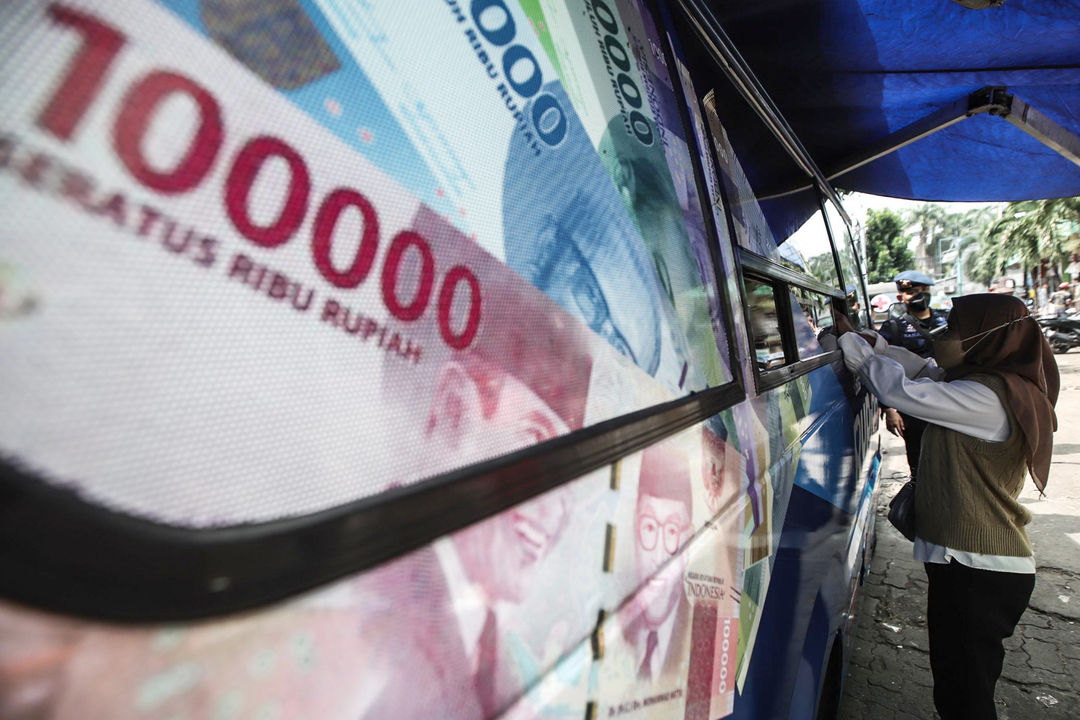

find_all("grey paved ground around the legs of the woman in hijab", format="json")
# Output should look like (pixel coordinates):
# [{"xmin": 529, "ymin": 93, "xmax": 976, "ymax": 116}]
[{"xmin": 839, "ymin": 350, "xmax": 1080, "ymax": 720}]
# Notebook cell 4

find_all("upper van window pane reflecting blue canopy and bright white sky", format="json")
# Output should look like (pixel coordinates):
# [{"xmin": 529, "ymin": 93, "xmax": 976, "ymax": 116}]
[{"xmin": 704, "ymin": 93, "xmax": 838, "ymax": 287}]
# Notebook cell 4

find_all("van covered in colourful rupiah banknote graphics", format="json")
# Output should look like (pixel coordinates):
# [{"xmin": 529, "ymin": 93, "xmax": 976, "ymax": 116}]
[{"xmin": 0, "ymin": 0, "xmax": 879, "ymax": 720}]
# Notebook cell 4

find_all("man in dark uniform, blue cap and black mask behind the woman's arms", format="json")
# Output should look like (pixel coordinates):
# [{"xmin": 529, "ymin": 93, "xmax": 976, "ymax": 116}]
[{"xmin": 878, "ymin": 270, "xmax": 948, "ymax": 479}]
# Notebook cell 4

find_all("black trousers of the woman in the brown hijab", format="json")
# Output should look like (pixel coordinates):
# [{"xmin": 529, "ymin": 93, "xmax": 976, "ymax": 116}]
[{"xmin": 926, "ymin": 560, "xmax": 1035, "ymax": 720}]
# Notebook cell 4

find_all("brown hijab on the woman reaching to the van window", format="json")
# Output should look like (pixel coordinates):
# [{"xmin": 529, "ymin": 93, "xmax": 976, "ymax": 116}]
[{"xmin": 945, "ymin": 293, "xmax": 1061, "ymax": 492}]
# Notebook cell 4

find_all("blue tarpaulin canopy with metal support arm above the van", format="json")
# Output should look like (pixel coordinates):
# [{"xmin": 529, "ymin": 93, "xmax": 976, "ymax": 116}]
[{"xmin": 707, "ymin": 0, "xmax": 1080, "ymax": 201}]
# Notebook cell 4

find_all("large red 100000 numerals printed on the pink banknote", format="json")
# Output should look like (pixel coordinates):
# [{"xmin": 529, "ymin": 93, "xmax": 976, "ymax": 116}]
[{"xmin": 37, "ymin": 4, "xmax": 481, "ymax": 350}]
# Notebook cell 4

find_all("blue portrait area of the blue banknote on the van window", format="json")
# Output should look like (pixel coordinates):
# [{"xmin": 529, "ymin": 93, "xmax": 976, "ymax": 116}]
[{"xmin": 503, "ymin": 82, "xmax": 663, "ymax": 376}]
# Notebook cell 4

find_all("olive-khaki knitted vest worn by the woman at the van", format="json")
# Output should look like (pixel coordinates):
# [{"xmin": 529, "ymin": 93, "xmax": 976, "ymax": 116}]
[{"xmin": 915, "ymin": 373, "xmax": 1032, "ymax": 557}]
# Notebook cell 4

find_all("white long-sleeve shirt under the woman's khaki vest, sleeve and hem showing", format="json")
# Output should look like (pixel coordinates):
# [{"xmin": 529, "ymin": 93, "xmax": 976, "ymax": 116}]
[{"xmin": 839, "ymin": 332, "xmax": 1035, "ymax": 574}]
